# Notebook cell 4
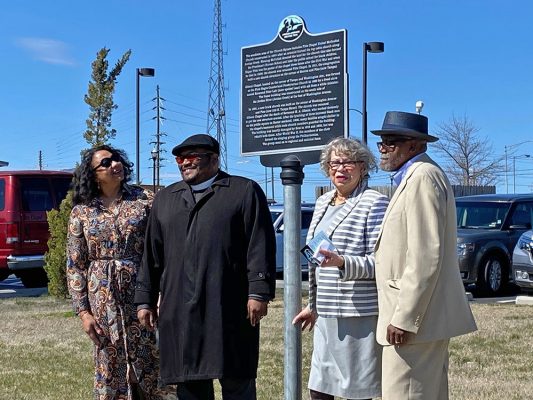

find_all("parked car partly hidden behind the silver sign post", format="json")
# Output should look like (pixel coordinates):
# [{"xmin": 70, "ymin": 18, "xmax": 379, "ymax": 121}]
[{"xmin": 269, "ymin": 203, "xmax": 315, "ymax": 276}]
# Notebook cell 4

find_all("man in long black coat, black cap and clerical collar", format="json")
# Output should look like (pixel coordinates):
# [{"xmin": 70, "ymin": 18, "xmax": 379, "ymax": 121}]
[{"xmin": 135, "ymin": 134, "xmax": 276, "ymax": 400}]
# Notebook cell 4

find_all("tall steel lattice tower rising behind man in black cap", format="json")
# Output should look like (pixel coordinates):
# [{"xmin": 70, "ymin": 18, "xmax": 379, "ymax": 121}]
[{"xmin": 207, "ymin": 0, "xmax": 228, "ymax": 171}]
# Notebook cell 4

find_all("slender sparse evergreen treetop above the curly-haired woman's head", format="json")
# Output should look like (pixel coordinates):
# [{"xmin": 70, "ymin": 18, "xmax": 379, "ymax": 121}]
[{"xmin": 83, "ymin": 47, "xmax": 131, "ymax": 147}]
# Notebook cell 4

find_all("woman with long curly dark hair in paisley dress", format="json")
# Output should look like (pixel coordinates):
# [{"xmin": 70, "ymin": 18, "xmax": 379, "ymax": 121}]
[{"xmin": 67, "ymin": 145, "xmax": 170, "ymax": 400}]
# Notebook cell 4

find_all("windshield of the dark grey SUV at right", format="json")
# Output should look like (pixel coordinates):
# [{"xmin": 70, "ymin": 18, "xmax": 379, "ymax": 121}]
[{"xmin": 456, "ymin": 201, "xmax": 510, "ymax": 229}]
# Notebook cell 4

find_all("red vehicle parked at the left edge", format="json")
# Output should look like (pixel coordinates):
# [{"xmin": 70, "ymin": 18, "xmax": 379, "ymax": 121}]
[{"xmin": 0, "ymin": 171, "xmax": 72, "ymax": 287}]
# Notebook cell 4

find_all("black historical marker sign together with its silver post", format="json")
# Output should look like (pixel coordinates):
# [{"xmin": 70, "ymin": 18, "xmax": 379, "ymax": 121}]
[{"xmin": 241, "ymin": 15, "xmax": 348, "ymax": 400}]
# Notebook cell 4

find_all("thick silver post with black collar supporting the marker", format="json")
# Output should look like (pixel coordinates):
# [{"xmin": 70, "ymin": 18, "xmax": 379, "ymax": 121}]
[{"xmin": 280, "ymin": 155, "xmax": 304, "ymax": 400}]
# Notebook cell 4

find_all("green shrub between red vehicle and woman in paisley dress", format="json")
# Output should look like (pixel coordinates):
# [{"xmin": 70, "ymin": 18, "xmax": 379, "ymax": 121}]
[{"xmin": 44, "ymin": 192, "xmax": 72, "ymax": 299}]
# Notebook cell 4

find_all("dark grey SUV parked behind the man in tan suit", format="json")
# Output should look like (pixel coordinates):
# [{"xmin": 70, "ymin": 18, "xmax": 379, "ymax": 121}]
[{"xmin": 456, "ymin": 194, "xmax": 533, "ymax": 295}]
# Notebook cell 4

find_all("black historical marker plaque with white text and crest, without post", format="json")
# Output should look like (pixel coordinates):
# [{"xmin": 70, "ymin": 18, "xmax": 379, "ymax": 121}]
[{"xmin": 241, "ymin": 15, "xmax": 348, "ymax": 162}]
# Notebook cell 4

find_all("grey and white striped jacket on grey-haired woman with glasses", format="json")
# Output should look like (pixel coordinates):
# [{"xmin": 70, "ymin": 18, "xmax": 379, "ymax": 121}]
[{"xmin": 307, "ymin": 182, "xmax": 389, "ymax": 318}]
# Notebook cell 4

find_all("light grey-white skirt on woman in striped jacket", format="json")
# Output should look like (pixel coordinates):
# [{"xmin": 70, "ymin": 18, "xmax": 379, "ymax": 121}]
[{"xmin": 308, "ymin": 316, "xmax": 381, "ymax": 399}]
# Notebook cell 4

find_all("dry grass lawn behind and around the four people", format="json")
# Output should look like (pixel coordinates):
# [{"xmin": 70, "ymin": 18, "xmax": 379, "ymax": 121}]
[{"xmin": 0, "ymin": 292, "xmax": 533, "ymax": 400}]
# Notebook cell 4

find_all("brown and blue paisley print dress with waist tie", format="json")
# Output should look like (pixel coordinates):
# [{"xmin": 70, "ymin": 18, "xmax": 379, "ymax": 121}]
[{"xmin": 67, "ymin": 185, "xmax": 164, "ymax": 400}]
